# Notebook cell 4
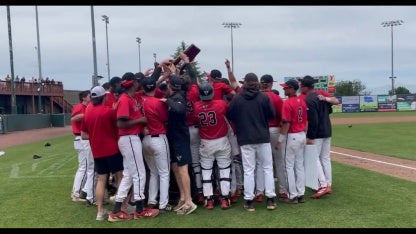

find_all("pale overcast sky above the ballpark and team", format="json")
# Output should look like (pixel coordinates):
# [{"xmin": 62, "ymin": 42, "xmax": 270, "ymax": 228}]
[{"xmin": 0, "ymin": 5, "xmax": 416, "ymax": 94}]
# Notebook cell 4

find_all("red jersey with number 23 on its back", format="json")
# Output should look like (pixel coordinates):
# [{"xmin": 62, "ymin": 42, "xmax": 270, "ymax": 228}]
[{"xmin": 194, "ymin": 99, "xmax": 228, "ymax": 139}]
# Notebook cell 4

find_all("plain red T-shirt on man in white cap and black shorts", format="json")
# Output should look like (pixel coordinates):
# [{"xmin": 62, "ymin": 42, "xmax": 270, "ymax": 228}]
[{"xmin": 82, "ymin": 104, "xmax": 119, "ymax": 158}]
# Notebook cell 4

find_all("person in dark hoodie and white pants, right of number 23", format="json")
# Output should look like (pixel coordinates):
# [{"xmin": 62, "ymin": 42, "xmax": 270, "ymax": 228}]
[{"xmin": 227, "ymin": 73, "xmax": 276, "ymax": 211}]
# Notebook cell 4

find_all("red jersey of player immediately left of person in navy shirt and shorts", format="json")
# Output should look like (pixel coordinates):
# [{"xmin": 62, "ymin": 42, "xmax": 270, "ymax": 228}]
[{"xmin": 143, "ymin": 96, "xmax": 168, "ymax": 135}]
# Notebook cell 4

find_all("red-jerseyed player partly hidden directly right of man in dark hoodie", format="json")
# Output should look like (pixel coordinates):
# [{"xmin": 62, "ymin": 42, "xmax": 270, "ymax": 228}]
[{"xmin": 256, "ymin": 74, "xmax": 287, "ymax": 200}]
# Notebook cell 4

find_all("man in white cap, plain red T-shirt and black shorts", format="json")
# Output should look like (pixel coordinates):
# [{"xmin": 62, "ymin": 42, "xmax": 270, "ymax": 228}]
[{"xmin": 81, "ymin": 86, "xmax": 123, "ymax": 221}]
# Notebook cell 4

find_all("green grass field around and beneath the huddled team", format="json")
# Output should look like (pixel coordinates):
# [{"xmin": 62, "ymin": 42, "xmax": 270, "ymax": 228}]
[{"xmin": 0, "ymin": 112, "xmax": 416, "ymax": 228}]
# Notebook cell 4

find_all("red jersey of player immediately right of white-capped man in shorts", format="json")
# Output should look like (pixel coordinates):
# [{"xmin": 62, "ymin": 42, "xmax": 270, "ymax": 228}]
[{"xmin": 117, "ymin": 92, "xmax": 143, "ymax": 136}]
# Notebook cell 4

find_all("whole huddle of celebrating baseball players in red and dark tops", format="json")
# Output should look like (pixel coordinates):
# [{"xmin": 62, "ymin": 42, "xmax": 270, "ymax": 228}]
[{"xmin": 71, "ymin": 52, "xmax": 338, "ymax": 222}]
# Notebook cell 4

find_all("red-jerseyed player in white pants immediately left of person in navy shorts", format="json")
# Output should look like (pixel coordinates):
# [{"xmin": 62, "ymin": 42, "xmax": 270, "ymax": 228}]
[{"xmin": 141, "ymin": 77, "xmax": 172, "ymax": 212}]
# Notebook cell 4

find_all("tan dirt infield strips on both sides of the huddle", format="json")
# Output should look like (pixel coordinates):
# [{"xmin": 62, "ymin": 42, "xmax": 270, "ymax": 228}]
[{"xmin": 0, "ymin": 116, "xmax": 416, "ymax": 182}]
